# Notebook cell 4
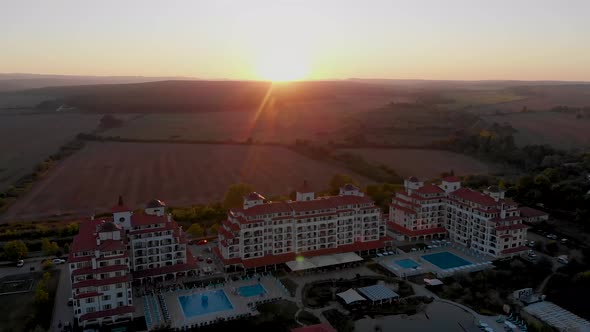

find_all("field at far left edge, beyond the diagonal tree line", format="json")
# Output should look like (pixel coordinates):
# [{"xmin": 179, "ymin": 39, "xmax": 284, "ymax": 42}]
[{"xmin": 0, "ymin": 113, "xmax": 100, "ymax": 191}]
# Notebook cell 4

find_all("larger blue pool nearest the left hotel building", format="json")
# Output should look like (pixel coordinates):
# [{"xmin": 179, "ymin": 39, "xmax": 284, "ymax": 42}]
[{"xmin": 178, "ymin": 289, "xmax": 234, "ymax": 318}]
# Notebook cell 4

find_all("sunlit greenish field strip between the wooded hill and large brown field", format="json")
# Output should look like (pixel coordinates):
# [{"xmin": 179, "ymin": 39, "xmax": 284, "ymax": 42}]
[{"xmin": 102, "ymin": 97, "xmax": 396, "ymax": 144}]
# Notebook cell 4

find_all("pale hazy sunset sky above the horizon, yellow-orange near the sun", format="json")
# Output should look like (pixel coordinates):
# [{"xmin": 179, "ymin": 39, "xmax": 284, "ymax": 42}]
[{"xmin": 0, "ymin": 0, "xmax": 590, "ymax": 81}]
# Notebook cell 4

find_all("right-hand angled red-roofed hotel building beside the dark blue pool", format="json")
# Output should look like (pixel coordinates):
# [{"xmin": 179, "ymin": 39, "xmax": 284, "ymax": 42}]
[{"xmin": 387, "ymin": 177, "xmax": 546, "ymax": 258}]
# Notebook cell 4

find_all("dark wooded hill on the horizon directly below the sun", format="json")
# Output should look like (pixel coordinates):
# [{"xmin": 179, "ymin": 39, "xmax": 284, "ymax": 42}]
[{"xmin": 26, "ymin": 81, "xmax": 396, "ymax": 113}]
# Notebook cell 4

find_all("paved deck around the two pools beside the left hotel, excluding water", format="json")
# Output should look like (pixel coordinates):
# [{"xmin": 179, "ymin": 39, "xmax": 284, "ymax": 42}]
[{"xmin": 157, "ymin": 276, "xmax": 287, "ymax": 330}]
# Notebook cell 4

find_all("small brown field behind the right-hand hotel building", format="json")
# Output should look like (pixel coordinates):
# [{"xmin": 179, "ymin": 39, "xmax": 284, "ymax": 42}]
[{"xmin": 338, "ymin": 149, "xmax": 492, "ymax": 180}]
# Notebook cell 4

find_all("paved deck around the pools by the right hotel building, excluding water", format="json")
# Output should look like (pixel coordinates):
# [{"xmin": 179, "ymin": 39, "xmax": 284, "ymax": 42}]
[{"xmin": 374, "ymin": 245, "xmax": 492, "ymax": 278}]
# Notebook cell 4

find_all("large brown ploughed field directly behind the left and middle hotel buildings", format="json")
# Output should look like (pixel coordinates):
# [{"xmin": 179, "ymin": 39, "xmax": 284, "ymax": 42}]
[{"xmin": 2, "ymin": 142, "xmax": 370, "ymax": 222}]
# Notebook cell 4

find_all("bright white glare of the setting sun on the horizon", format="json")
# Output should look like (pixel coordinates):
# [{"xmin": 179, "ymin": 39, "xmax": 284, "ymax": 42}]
[{"xmin": 256, "ymin": 51, "xmax": 309, "ymax": 82}]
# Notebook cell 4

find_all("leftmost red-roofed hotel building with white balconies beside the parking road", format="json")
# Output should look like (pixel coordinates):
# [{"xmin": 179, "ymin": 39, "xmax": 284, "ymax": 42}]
[{"xmin": 68, "ymin": 198, "xmax": 197, "ymax": 326}]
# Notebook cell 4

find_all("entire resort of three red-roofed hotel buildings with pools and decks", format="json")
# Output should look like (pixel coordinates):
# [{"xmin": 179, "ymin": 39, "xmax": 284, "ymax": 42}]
[{"xmin": 68, "ymin": 182, "xmax": 568, "ymax": 331}]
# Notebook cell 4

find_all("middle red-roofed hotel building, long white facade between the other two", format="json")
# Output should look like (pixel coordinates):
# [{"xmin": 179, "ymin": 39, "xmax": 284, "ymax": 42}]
[{"xmin": 216, "ymin": 183, "xmax": 391, "ymax": 271}]
